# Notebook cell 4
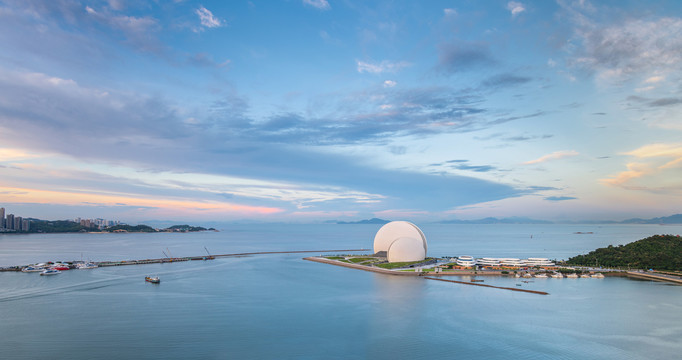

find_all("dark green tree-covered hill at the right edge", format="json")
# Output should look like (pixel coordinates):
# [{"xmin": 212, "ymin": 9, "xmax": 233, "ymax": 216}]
[{"xmin": 566, "ymin": 235, "xmax": 682, "ymax": 271}]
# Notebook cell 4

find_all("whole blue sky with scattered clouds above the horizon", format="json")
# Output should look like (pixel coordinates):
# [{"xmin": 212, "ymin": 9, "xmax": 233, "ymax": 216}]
[{"xmin": 0, "ymin": 0, "xmax": 682, "ymax": 223}]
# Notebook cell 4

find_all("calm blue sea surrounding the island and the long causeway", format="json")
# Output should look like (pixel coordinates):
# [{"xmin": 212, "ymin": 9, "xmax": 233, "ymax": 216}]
[{"xmin": 0, "ymin": 224, "xmax": 682, "ymax": 359}]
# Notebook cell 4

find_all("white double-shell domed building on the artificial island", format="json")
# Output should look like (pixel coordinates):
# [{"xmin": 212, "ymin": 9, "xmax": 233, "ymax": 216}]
[{"xmin": 374, "ymin": 221, "xmax": 427, "ymax": 262}]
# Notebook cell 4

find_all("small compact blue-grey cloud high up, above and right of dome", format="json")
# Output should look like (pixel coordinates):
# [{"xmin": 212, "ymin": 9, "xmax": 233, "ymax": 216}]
[{"xmin": 436, "ymin": 42, "xmax": 496, "ymax": 73}]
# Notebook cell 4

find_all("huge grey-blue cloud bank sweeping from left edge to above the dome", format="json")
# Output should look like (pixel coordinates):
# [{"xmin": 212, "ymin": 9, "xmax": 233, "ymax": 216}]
[{"xmin": 0, "ymin": 69, "xmax": 519, "ymax": 213}]
